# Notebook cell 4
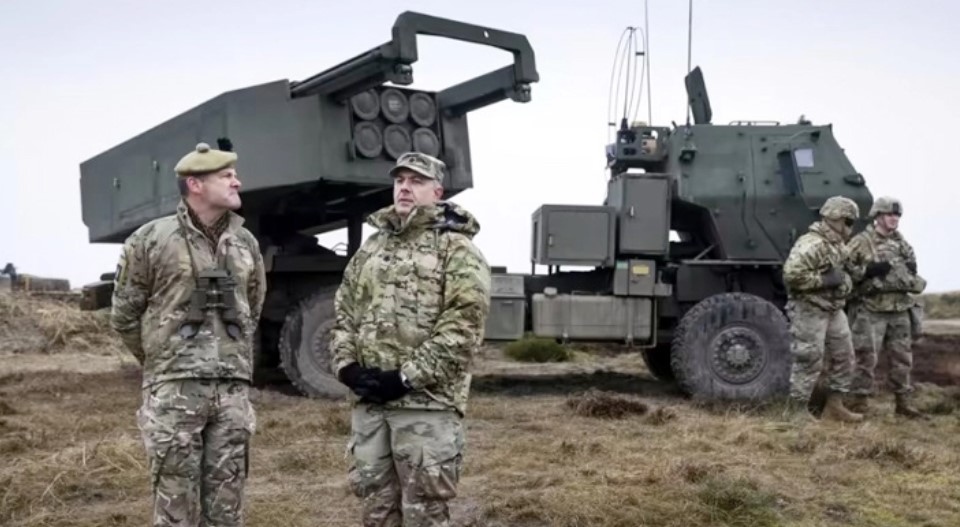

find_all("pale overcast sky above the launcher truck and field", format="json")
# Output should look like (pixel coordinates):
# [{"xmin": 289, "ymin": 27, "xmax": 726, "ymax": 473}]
[{"xmin": 0, "ymin": 0, "xmax": 960, "ymax": 291}]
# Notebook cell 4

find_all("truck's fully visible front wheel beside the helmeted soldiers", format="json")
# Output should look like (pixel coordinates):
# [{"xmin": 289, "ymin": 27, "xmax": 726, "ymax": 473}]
[{"xmin": 670, "ymin": 293, "xmax": 792, "ymax": 401}]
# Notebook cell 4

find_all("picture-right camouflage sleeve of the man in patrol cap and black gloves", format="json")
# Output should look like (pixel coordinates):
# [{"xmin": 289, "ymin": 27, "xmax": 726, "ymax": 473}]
[{"xmin": 400, "ymin": 237, "xmax": 491, "ymax": 389}]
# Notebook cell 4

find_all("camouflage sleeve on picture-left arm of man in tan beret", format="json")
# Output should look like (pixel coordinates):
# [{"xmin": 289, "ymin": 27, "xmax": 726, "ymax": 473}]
[{"xmin": 110, "ymin": 233, "xmax": 152, "ymax": 364}]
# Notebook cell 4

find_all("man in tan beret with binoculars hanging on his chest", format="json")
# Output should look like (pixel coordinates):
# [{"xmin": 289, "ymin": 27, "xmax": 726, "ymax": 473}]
[{"xmin": 111, "ymin": 143, "xmax": 266, "ymax": 526}]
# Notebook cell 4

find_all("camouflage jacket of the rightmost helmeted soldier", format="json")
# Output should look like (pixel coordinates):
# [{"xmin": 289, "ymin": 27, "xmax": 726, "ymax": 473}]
[{"xmin": 847, "ymin": 225, "xmax": 927, "ymax": 312}]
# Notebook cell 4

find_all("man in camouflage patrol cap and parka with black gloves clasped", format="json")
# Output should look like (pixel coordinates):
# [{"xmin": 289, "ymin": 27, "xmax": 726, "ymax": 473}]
[{"xmin": 331, "ymin": 153, "xmax": 491, "ymax": 527}]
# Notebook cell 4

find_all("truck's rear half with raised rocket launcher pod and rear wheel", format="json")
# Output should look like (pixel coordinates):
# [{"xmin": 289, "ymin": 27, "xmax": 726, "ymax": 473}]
[{"xmin": 80, "ymin": 12, "xmax": 539, "ymax": 396}]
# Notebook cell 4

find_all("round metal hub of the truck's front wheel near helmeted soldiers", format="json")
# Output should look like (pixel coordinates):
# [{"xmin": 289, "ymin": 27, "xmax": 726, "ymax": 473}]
[{"xmin": 710, "ymin": 327, "xmax": 766, "ymax": 384}]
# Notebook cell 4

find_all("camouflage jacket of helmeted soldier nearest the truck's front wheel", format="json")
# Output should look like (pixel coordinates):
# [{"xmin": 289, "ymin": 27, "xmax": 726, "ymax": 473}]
[{"xmin": 783, "ymin": 221, "xmax": 853, "ymax": 311}]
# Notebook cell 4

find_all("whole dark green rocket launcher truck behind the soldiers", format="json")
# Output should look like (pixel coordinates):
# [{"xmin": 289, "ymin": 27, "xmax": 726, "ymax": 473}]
[{"xmin": 81, "ymin": 12, "xmax": 872, "ymax": 399}]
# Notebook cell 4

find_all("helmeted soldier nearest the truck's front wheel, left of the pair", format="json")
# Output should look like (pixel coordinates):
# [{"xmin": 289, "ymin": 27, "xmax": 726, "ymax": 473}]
[{"xmin": 783, "ymin": 196, "xmax": 863, "ymax": 422}]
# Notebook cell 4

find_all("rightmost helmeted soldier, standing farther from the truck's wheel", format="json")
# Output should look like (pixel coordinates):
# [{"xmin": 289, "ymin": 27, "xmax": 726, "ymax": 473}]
[{"xmin": 848, "ymin": 197, "xmax": 927, "ymax": 417}]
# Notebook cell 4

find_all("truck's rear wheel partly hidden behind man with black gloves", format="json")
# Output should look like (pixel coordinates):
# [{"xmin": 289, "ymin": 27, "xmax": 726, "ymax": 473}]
[{"xmin": 279, "ymin": 287, "xmax": 350, "ymax": 400}]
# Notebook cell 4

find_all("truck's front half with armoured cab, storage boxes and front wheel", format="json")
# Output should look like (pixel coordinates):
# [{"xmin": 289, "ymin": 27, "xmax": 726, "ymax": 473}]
[{"xmin": 488, "ymin": 68, "xmax": 872, "ymax": 399}]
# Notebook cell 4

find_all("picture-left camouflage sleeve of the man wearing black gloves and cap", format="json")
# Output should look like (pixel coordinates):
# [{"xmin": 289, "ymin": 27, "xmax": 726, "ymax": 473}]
[{"xmin": 330, "ymin": 237, "xmax": 373, "ymax": 375}]
